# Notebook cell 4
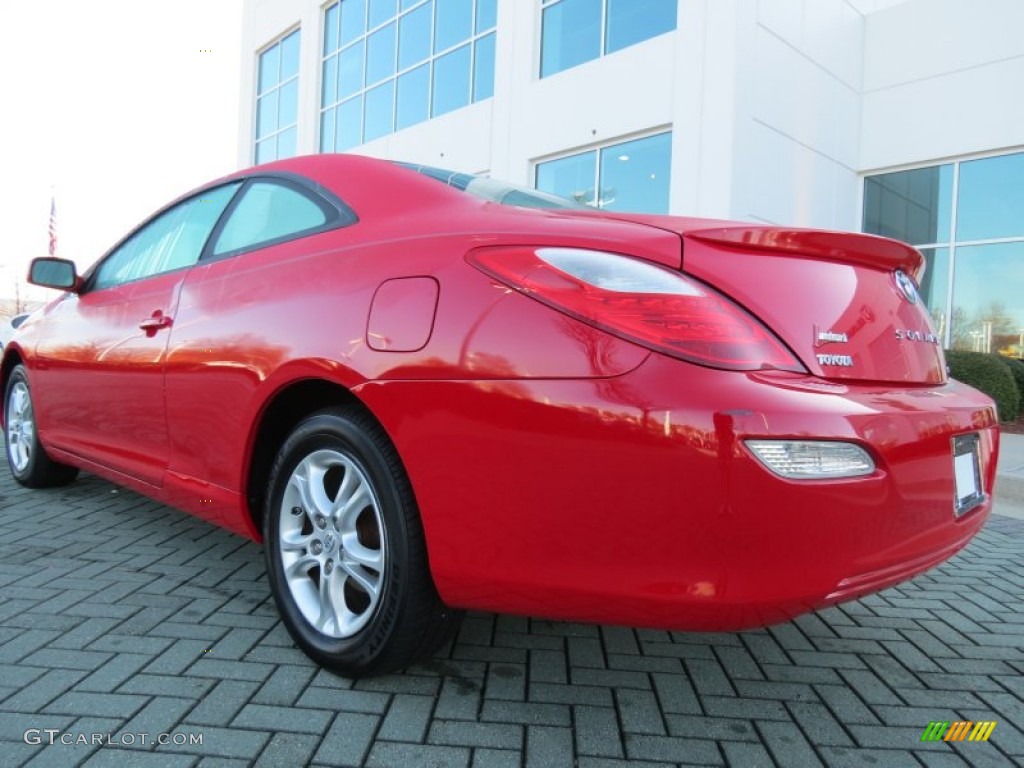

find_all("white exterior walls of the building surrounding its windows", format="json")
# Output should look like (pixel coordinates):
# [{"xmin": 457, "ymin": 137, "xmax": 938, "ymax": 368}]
[{"xmin": 240, "ymin": 0, "xmax": 1024, "ymax": 229}]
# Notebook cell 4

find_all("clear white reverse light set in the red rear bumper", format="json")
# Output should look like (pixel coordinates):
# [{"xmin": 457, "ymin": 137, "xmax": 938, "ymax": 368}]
[{"xmin": 744, "ymin": 440, "xmax": 874, "ymax": 480}]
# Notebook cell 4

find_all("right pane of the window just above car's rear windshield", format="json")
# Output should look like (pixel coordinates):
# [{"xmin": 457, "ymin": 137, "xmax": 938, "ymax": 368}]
[{"xmin": 598, "ymin": 133, "xmax": 672, "ymax": 213}]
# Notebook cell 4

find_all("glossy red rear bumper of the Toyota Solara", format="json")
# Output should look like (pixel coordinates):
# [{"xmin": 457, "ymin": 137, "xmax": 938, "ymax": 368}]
[{"xmin": 358, "ymin": 355, "xmax": 998, "ymax": 631}]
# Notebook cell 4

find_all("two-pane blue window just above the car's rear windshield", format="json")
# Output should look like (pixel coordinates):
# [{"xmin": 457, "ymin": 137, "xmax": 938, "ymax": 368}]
[{"xmin": 536, "ymin": 133, "xmax": 672, "ymax": 213}]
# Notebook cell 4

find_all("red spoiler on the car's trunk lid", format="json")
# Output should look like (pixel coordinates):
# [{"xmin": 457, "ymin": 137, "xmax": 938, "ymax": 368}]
[{"xmin": 683, "ymin": 226, "xmax": 925, "ymax": 280}]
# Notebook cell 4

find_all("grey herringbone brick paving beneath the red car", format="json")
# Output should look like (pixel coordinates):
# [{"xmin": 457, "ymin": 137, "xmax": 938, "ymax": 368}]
[{"xmin": 0, "ymin": 471, "xmax": 1024, "ymax": 768}]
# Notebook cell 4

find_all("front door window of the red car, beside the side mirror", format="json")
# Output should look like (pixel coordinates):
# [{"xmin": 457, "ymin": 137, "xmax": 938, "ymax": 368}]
[{"xmin": 90, "ymin": 182, "xmax": 242, "ymax": 290}]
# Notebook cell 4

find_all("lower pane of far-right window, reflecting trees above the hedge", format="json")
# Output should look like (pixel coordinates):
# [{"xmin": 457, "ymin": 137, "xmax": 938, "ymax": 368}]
[{"xmin": 952, "ymin": 243, "xmax": 1024, "ymax": 354}]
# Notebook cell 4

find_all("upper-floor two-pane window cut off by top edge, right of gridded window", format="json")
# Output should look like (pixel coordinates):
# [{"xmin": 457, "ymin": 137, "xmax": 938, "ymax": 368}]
[{"xmin": 541, "ymin": 0, "xmax": 679, "ymax": 78}]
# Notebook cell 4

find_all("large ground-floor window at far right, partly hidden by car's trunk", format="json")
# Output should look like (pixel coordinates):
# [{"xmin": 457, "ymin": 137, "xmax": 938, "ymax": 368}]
[{"xmin": 864, "ymin": 153, "xmax": 1024, "ymax": 357}]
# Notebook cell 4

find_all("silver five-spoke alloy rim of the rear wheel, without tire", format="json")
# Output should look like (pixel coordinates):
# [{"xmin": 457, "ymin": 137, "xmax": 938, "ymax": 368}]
[{"xmin": 279, "ymin": 450, "xmax": 387, "ymax": 638}]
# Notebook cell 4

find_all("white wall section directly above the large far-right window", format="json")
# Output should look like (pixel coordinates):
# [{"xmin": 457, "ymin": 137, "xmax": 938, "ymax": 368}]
[{"xmin": 860, "ymin": 0, "xmax": 1024, "ymax": 171}]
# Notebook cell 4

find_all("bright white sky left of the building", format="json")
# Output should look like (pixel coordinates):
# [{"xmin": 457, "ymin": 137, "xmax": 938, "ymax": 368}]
[{"xmin": 0, "ymin": 0, "xmax": 242, "ymax": 307}]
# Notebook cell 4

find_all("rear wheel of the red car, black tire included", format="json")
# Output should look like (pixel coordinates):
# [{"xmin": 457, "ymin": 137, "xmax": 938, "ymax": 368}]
[{"xmin": 263, "ymin": 406, "xmax": 461, "ymax": 678}]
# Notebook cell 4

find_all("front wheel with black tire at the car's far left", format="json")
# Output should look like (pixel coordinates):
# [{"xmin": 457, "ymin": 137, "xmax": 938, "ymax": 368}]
[{"xmin": 3, "ymin": 366, "xmax": 78, "ymax": 488}]
